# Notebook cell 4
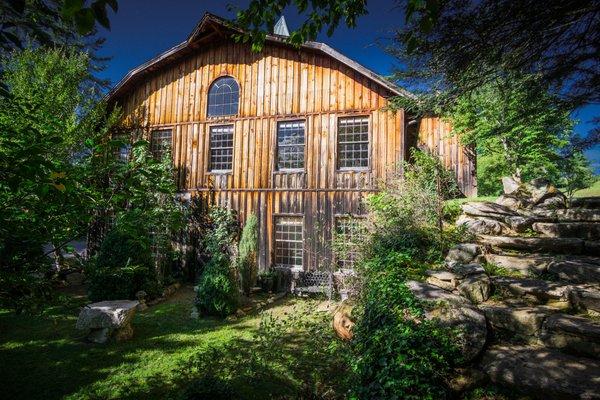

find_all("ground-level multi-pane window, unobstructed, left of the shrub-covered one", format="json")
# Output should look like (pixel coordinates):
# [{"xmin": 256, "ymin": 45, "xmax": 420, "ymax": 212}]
[{"xmin": 275, "ymin": 217, "xmax": 303, "ymax": 269}]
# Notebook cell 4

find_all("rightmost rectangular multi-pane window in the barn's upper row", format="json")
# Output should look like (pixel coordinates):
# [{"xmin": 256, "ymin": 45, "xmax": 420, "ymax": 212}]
[{"xmin": 337, "ymin": 117, "xmax": 369, "ymax": 169}]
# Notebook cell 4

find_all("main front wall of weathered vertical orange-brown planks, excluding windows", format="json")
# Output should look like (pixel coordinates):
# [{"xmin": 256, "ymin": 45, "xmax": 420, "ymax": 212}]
[{"xmin": 118, "ymin": 41, "xmax": 405, "ymax": 270}]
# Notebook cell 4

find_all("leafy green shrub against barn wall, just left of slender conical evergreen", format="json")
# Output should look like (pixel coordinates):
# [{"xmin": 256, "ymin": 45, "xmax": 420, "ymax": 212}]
[{"xmin": 196, "ymin": 207, "xmax": 240, "ymax": 317}]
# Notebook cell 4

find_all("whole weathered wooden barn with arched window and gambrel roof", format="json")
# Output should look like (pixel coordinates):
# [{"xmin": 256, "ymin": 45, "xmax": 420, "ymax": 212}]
[{"xmin": 109, "ymin": 14, "xmax": 476, "ymax": 271}]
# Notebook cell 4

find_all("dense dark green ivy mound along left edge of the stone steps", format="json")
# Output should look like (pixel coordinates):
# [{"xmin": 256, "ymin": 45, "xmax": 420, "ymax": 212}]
[{"xmin": 352, "ymin": 253, "xmax": 458, "ymax": 399}]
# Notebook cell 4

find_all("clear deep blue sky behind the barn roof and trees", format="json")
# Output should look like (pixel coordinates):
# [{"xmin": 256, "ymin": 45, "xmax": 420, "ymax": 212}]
[{"xmin": 100, "ymin": 0, "xmax": 600, "ymax": 172}]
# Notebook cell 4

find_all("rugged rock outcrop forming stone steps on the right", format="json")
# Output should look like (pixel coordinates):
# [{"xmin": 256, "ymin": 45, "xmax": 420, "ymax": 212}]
[{"xmin": 436, "ymin": 178, "xmax": 600, "ymax": 399}]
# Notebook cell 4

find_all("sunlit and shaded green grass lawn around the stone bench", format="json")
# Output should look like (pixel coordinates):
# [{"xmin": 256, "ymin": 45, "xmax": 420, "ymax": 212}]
[{"xmin": 0, "ymin": 288, "xmax": 340, "ymax": 399}]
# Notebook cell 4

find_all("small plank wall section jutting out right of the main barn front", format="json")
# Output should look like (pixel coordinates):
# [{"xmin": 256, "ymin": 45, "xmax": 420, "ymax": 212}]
[{"xmin": 418, "ymin": 117, "xmax": 477, "ymax": 197}]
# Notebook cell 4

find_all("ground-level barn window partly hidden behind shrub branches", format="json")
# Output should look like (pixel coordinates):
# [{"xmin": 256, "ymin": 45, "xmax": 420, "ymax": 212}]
[{"xmin": 333, "ymin": 217, "xmax": 363, "ymax": 270}]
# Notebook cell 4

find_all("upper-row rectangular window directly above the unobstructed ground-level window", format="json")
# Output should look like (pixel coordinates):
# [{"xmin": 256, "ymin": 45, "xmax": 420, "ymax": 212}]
[{"xmin": 277, "ymin": 121, "xmax": 304, "ymax": 170}]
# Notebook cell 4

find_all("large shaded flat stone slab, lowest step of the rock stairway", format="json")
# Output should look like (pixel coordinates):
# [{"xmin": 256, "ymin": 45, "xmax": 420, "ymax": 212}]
[{"xmin": 481, "ymin": 345, "xmax": 600, "ymax": 400}]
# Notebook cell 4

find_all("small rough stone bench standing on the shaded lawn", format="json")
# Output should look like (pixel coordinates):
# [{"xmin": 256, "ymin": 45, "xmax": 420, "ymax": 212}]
[{"xmin": 75, "ymin": 300, "xmax": 139, "ymax": 343}]
